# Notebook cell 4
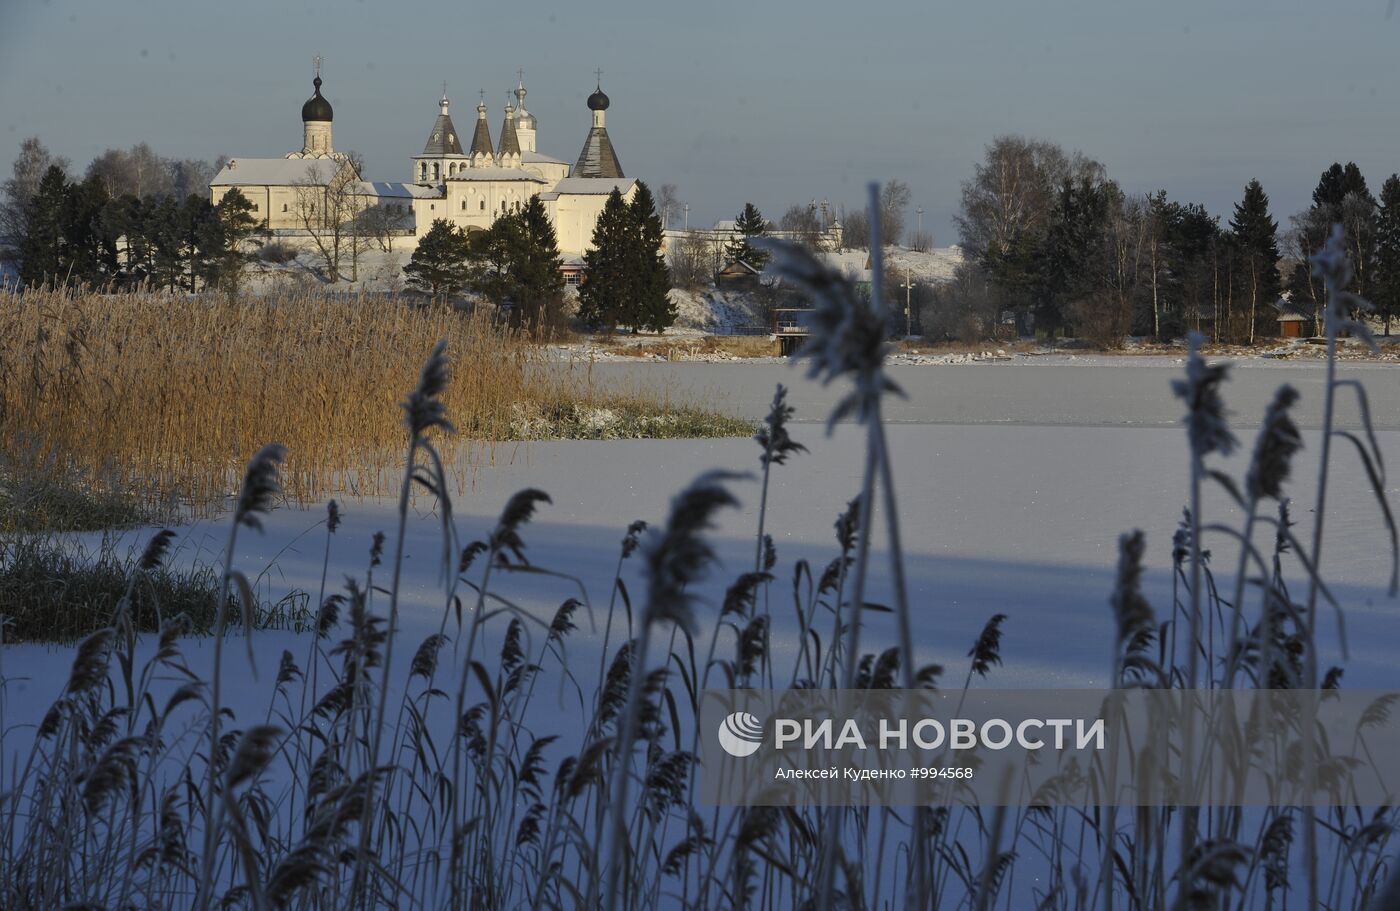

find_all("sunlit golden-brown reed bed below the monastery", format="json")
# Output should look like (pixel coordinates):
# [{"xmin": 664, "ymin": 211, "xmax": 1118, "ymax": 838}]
[{"xmin": 0, "ymin": 288, "xmax": 752, "ymax": 508}]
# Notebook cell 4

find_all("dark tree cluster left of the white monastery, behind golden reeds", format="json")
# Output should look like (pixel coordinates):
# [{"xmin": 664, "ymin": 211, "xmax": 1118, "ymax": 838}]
[{"xmin": 0, "ymin": 139, "xmax": 259, "ymax": 291}]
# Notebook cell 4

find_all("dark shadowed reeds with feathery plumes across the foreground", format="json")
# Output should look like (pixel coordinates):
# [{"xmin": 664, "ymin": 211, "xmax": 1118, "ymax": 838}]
[{"xmin": 0, "ymin": 220, "xmax": 1394, "ymax": 911}]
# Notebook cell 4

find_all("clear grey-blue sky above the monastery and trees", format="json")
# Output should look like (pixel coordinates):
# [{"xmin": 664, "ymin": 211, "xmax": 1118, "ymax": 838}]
[{"xmin": 0, "ymin": 0, "xmax": 1400, "ymax": 246}]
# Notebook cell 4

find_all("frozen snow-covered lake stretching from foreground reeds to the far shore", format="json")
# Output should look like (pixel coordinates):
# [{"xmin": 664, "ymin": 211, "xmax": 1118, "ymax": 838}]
[{"xmin": 0, "ymin": 361, "xmax": 1400, "ymax": 726}]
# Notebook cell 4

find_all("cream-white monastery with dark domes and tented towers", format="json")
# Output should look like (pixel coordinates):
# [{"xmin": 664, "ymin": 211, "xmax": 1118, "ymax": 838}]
[{"xmin": 209, "ymin": 71, "xmax": 637, "ymax": 273}]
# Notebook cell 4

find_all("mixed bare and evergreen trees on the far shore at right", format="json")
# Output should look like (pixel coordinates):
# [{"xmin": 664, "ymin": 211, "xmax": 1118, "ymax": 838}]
[{"xmin": 946, "ymin": 136, "xmax": 1400, "ymax": 343}]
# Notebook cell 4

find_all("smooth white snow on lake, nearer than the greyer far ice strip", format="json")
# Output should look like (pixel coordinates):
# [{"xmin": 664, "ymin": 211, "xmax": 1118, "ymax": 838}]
[{"xmin": 3, "ymin": 425, "xmax": 1400, "ymax": 699}]
